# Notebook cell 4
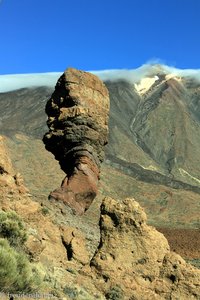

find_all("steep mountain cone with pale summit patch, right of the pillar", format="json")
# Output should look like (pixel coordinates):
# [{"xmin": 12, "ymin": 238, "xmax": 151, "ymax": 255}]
[{"xmin": 107, "ymin": 70, "xmax": 200, "ymax": 186}]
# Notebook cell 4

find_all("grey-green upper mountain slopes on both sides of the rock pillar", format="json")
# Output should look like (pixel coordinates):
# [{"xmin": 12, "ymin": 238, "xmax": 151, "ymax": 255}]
[{"xmin": 0, "ymin": 66, "xmax": 200, "ymax": 186}]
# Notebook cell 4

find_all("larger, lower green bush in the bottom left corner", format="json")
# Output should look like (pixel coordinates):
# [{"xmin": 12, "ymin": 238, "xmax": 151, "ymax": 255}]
[{"xmin": 0, "ymin": 239, "xmax": 40, "ymax": 292}]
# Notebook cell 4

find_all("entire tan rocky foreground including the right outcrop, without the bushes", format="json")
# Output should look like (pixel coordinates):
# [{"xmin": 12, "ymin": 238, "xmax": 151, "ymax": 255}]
[{"xmin": 0, "ymin": 145, "xmax": 200, "ymax": 300}]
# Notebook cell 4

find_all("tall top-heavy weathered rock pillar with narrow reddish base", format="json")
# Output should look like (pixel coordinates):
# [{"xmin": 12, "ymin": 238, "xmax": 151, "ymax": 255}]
[{"xmin": 43, "ymin": 68, "xmax": 109, "ymax": 214}]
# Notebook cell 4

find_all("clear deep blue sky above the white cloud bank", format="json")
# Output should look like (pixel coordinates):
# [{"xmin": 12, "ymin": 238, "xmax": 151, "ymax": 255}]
[{"xmin": 0, "ymin": 0, "xmax": 200, "ymax": 74}]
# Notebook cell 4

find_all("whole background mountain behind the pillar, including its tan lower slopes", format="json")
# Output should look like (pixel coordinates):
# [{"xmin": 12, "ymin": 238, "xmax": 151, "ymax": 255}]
[{"xmin": 0, "ymin": 66, "xmax": 200, "ymax": 228}]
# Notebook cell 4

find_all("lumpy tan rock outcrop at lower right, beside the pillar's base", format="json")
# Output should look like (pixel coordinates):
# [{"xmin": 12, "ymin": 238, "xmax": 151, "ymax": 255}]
[{"xmin": 91, "ymin": 197, "xmax": 200, "ymax": 300}]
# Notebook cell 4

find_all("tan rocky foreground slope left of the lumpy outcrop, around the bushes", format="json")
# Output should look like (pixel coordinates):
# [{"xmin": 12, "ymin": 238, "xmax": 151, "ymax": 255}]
[{"xmin": 0, "ymin": 137, "xmax": 103, "ymax": 299}]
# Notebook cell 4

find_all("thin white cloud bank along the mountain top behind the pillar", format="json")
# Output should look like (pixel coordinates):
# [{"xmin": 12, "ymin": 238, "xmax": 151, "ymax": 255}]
[{"xmin": 0, "ymin": 63, "xmax": 200, "ymax": 93}]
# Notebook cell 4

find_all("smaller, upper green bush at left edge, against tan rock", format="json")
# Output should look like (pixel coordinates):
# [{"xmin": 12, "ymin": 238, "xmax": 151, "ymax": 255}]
[{"xmin": 0, "ymin": 211, "xmax": 27, "ymax": 246}]
